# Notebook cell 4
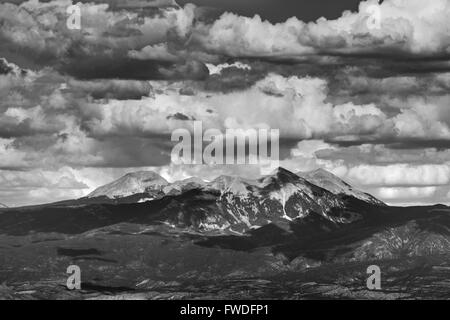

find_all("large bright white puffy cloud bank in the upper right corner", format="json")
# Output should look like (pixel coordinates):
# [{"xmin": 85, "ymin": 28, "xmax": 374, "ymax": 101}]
[{"xmin": 195, "ymin": 0, "xmax": 450, "ymax": 59}]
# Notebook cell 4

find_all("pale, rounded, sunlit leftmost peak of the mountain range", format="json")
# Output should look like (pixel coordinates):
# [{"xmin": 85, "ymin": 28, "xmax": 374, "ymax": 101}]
[{"xmin": 88, "ymin": 171, "xmax": 169, "ymax": 199}]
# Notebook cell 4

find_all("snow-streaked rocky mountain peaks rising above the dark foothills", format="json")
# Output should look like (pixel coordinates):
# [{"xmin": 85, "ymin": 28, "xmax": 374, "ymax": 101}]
[{"xmin": 58, "ymin": 168, "xmax": 385, "ymax": 232}]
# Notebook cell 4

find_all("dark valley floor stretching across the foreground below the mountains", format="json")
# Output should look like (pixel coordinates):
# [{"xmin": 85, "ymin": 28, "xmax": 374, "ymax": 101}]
[{"xmin": 0, "ymin": 224, "xmax": 450, "ymax": 300}]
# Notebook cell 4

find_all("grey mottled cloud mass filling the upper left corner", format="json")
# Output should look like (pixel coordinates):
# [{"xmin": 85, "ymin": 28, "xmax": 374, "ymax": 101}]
[{"xmin": 0, "ymin": 0, "xmax": 200, "ymax": 79}]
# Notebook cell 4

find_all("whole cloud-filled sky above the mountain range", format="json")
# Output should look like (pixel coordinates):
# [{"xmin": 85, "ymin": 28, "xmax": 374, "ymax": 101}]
[{"xmin": 0, "ymin": 0, "xmax": 450, "ymax": 206}]
